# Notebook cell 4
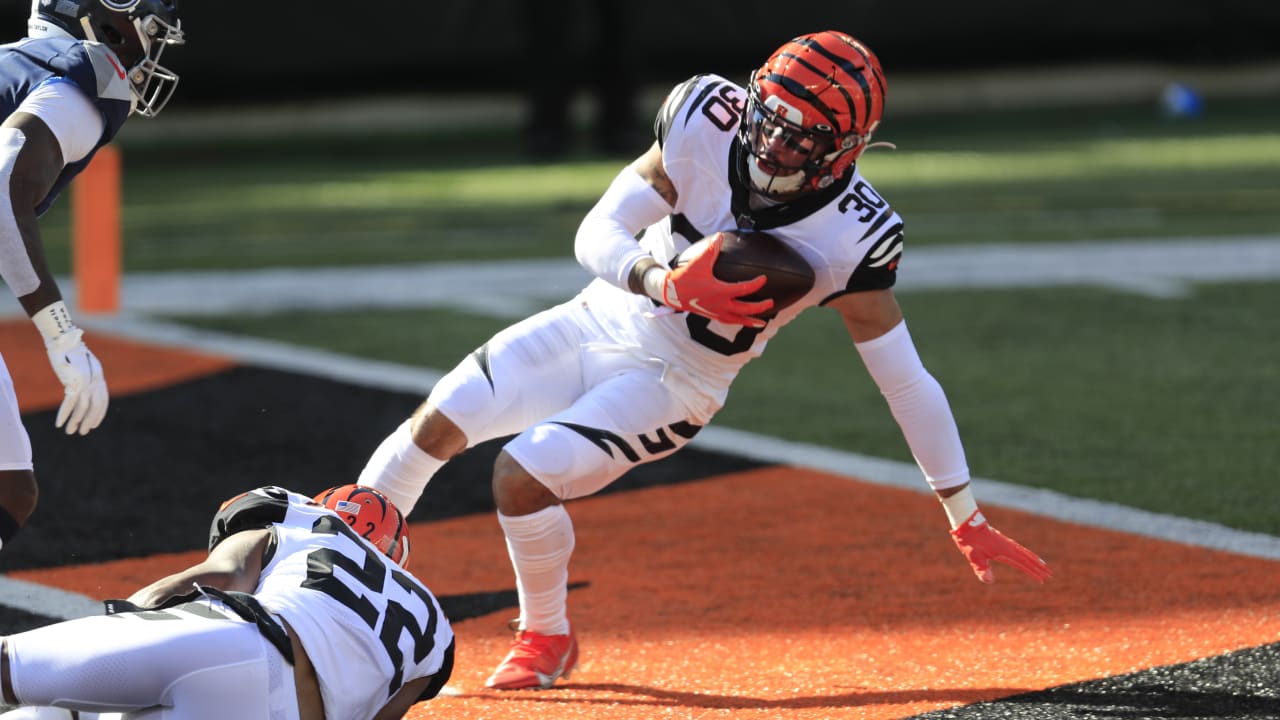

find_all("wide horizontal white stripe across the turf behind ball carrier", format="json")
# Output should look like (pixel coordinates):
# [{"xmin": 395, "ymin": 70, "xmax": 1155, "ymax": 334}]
[{"xmin": 0, "ymin": 236, "xmax": 1280, "ymax": 319}]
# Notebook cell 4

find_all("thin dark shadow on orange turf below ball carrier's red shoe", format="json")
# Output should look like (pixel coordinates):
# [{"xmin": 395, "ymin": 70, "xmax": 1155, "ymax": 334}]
[{"xmin": 458, "ymin": 683, "xmax": 1028, "ymax": 710}]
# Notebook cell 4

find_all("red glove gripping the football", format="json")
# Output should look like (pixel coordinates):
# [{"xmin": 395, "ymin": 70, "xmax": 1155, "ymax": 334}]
[{"xmin": 662, "ymin": 234, "xmax": 773, "ymax": 328}]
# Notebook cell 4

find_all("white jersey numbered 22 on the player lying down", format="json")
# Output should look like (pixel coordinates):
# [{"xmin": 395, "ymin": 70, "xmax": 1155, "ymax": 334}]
[{"xmin": 211, "ymin": 487, "xmax": 453, "ymax": 719}]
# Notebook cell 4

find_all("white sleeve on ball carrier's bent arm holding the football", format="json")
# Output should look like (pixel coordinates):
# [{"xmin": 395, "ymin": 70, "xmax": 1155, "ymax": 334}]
[{"xmin": 573, "ymin": 168, "xmax": 672, "ymax": 292}]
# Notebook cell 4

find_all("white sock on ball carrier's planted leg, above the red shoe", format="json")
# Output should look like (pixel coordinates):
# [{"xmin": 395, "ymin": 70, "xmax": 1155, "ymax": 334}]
[{"xmin": 498, "ymin": 505, "xmax": 573, "ymax": 635}]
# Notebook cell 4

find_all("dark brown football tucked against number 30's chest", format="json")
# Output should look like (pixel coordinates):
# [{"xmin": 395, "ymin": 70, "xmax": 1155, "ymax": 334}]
[{"xmin": 671, "ymin": 231, "xmax": 814, "ymax": 320}]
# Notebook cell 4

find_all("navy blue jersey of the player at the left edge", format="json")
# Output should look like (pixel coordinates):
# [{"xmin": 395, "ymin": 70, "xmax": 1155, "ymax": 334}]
[{"xmin": 0, "ymin": 37, "xmax": 132, "ymax": 215}]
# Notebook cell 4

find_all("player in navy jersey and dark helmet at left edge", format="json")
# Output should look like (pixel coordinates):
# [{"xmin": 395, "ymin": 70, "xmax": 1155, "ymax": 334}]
[{"xmin": 0, "ymin": 0, "xmax": 183, "ymax": 546}]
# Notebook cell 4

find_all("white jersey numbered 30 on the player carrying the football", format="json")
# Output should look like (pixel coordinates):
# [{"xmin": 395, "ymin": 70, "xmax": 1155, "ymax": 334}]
[{"xmin": 581, "ymin": 74, "xmax": 902, "ymax": 420}]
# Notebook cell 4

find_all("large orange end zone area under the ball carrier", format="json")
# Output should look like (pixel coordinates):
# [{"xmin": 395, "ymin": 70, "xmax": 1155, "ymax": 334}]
[{"xmin": 12, "ymin": 468, "xmax": 1280, "ymax": 720}]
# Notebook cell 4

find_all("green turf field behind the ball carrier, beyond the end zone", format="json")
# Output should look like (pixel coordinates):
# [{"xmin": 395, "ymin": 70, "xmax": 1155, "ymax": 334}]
[{"xmin": 60, "ymin": 94, "xmax": 1280, "ymax": 534}]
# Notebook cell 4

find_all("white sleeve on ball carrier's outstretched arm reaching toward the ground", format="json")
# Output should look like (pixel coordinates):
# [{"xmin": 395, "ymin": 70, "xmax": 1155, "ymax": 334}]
[{"xmin": 855, "ymin": 320, "xmax": 969, "ymax": 489}]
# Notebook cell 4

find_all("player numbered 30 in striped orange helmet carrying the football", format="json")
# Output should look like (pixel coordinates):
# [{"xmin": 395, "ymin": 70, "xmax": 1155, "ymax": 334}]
[{"xmin": 358, "ymin": 32, "xmax": 1050, "ymax": 689}]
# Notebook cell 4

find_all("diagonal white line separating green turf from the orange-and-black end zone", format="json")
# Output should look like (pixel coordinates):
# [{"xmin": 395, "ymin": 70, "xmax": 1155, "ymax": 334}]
[{"xmin": 77, "ymin": 318, "xmax": 1280, "ymax": 560}]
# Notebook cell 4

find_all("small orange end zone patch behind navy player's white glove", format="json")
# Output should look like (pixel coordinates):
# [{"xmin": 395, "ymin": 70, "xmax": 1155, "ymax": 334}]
[{"xmin": 0, "ymin": 319, "xmax": 236, "ymax": 413}]
